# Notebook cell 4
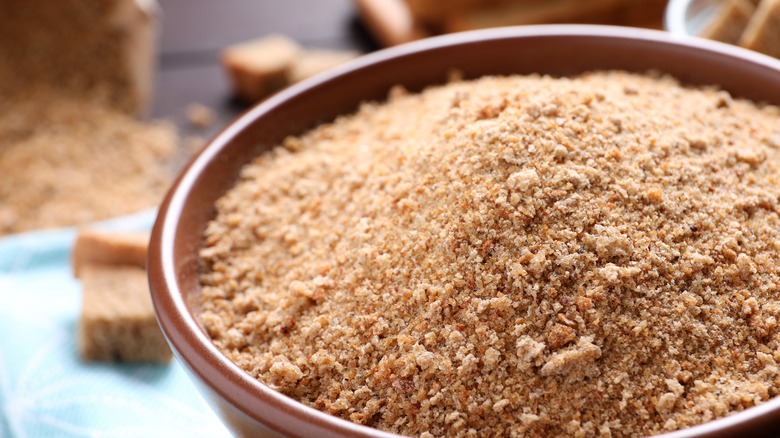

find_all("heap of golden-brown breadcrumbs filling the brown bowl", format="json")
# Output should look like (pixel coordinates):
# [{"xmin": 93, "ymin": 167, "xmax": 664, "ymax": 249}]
[{"xmin": 201, "ymin": 72, "xmax": 780, "ymax": 437}]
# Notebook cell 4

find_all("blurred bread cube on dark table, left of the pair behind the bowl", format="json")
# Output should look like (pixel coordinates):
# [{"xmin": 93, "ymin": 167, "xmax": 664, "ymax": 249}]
[{"xmin": 221, "ymin": 35, "xmax": 301, "ymax": 103}]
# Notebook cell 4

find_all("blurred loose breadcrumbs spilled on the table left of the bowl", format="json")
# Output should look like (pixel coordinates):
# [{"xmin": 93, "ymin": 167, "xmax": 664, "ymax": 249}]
[{"xmin": 0, "ymin": 94, "xmax": 178, "ymax": 236}]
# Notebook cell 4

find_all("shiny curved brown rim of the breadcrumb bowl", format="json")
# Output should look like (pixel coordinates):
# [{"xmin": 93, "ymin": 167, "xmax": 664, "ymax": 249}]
[{"xmin": 152, "ymin": 24, "xmax": 780, "ymax": 438}]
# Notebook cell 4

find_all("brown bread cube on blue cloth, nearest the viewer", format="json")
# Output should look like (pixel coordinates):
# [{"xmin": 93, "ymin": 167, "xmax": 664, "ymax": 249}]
[{"xmin": 78, "ymin": 264, "xmax": 172, "ymax": 362}]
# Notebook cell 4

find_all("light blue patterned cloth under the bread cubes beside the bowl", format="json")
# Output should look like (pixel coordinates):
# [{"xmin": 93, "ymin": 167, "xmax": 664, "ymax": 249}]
[{"xmin": 0, "ymin": 211, "xmax": 229, "ymax": 438}]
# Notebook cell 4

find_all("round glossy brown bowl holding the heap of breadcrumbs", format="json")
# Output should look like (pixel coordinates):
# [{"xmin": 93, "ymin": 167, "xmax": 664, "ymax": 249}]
[{"xmin": 148, "ymin": 25, "xmax": 780, "ymax": 437}]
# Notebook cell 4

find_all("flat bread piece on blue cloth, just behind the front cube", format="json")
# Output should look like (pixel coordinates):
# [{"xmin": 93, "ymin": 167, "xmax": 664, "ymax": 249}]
[{"xmin": 71, "ymin": 228, "xmax": 149, "ymax": 278}]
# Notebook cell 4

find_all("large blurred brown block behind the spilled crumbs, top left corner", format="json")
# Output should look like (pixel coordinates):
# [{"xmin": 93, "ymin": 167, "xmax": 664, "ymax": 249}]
[{"xmin": 0, "ymin": 0, "xmax": 157, "ymax": 115}]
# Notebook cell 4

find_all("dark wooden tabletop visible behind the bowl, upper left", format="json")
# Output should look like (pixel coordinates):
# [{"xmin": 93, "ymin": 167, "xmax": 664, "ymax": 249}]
[{"xmin": 150, "ymin": 0, "xmax": 377, "ymax": 138}]
